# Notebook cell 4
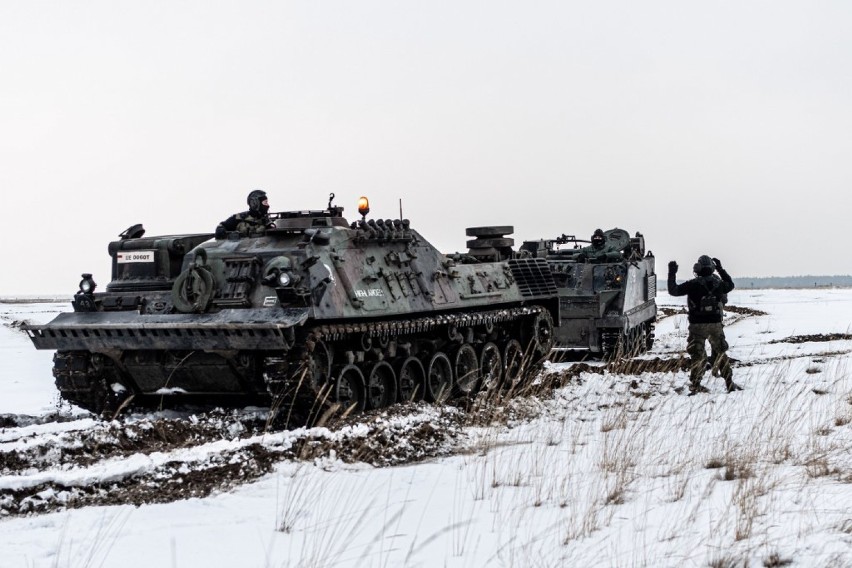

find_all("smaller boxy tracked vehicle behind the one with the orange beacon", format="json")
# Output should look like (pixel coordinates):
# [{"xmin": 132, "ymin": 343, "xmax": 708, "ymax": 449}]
[{"xmin": 521, "ymin": 228, "xmax": 657, "ymax": 357}]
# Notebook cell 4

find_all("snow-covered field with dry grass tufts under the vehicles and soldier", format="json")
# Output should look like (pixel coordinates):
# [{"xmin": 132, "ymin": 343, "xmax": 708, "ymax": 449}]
[{"xmin": 0, "ymin": 289, "xmax": 852, "ymax": 568}]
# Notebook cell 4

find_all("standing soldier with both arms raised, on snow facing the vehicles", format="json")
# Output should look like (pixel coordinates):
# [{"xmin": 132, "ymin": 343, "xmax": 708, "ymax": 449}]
[{"xmin": 668, "ymin": 255, "xmax": 742, "ymax": 394}]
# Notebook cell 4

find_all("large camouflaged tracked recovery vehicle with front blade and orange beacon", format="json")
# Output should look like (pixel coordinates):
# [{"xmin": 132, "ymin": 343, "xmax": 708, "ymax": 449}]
[{"xmin": 25, "ymin": 196, "xmax": 559, "ymax": 413}]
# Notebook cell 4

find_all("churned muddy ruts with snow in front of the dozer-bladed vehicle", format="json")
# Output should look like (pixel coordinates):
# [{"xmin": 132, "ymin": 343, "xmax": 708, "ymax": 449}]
[{"xmin": 0, "ymin": 405, "xmax": 462, "ymax": 517}]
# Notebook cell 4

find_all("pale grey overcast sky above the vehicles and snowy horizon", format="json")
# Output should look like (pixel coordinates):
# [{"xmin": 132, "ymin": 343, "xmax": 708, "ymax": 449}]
[{"xmin": 0, "ymin": 0, "xmax": 852, "ymax": 294}]
